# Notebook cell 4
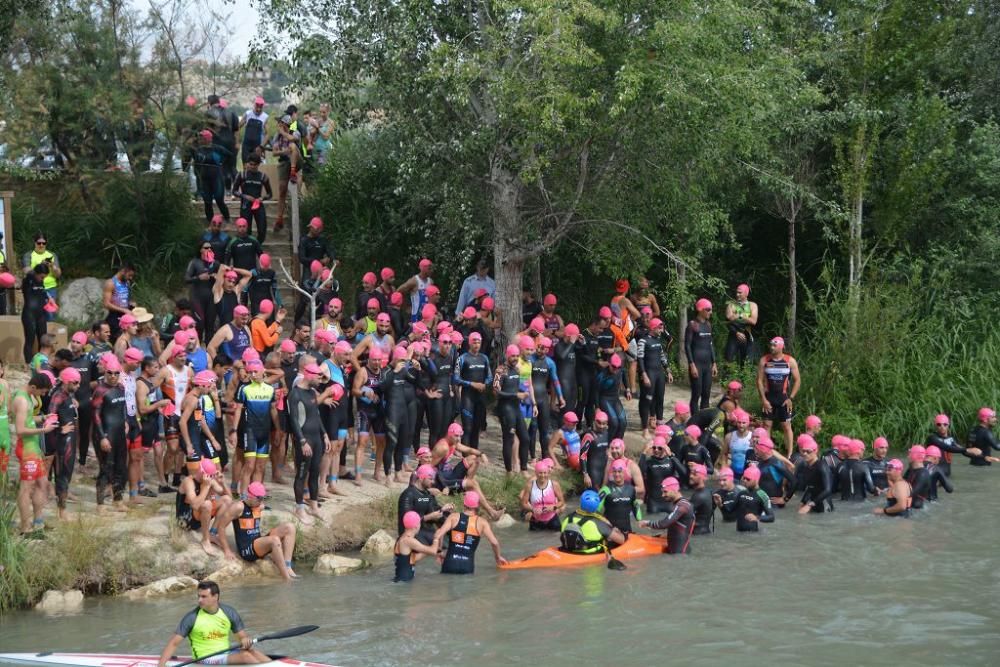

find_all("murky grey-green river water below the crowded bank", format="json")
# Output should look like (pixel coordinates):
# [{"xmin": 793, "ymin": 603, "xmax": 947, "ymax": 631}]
[{"xmin": 0, "ymin": 472, "xmax": 1000, "ymax": 667}]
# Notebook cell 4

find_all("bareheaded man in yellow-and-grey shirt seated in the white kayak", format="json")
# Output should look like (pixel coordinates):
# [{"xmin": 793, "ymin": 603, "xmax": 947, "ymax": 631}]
[{"xmin": 159, "ymin": 580, "xmax": 271, "ymax": 667}]
